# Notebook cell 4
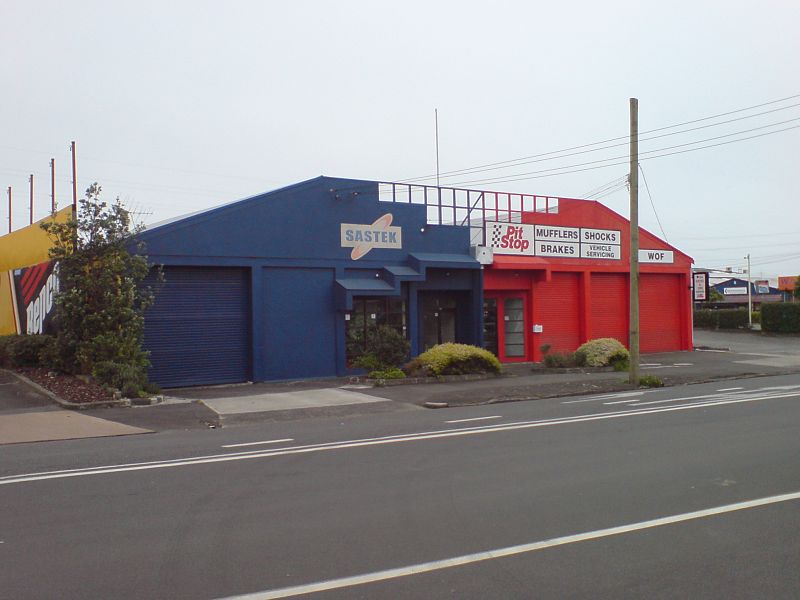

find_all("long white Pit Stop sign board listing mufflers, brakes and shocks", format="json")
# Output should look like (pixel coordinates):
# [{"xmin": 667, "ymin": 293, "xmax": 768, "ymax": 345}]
[{"xmin": 486, "ymin": 222, "xmax": 622, "ymax": 260}]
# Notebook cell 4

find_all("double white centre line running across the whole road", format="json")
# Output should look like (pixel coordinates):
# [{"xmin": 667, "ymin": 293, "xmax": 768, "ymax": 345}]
[{"xmin": 0, "ymin": 390, "xmax": 800, "ymax": 485}]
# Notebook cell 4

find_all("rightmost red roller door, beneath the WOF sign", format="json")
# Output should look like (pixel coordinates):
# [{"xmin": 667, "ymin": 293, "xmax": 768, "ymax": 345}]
[{"xmin": 639, "ymin": 273, "xmax": 681, "ymax": 352}]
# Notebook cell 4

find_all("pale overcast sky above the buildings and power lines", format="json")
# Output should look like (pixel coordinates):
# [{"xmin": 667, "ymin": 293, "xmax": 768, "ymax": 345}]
[{"xmin": 0, "ymin": 0, "xmax": 800, "ymax": 276}]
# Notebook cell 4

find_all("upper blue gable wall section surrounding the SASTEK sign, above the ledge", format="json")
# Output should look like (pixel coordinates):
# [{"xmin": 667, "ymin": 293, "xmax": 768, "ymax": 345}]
[{"xmin": 141, "ymin": 177, "xmax": 469, "ymax": 266}]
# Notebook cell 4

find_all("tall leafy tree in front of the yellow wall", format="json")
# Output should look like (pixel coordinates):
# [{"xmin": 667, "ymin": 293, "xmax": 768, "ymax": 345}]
[{"xmin": 42, "ymin": 183, "xmax": 154, "ymax": 395}]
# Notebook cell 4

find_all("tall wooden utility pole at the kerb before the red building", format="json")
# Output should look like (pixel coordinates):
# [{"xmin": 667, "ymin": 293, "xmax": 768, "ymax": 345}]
[{"xmin": 628, "ymin": 98, "xmax": 639, "ymax": 386}]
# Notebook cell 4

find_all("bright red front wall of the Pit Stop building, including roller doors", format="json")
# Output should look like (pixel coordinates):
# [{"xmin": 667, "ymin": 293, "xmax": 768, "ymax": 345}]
[{"xmin": 484, "ymin": 199, "xmax": 692, "ymax": 361}]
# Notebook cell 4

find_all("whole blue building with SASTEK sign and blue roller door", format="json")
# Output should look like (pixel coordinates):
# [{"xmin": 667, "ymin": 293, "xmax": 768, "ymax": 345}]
[{"xmin": 141, "ymin": 177, "xmax": 483, "ymax": 387}]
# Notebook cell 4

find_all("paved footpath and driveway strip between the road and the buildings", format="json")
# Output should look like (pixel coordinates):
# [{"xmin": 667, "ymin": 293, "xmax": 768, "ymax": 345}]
[{"xmin": 0, "ymin": 330, "xmax": 800, "ymax": 444}]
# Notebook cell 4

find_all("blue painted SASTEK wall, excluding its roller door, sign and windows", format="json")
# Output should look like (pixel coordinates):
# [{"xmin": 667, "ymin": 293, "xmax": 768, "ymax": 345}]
[{"xmin": 141, "ymin": 177, "xmax": 482, "ymax": 381}]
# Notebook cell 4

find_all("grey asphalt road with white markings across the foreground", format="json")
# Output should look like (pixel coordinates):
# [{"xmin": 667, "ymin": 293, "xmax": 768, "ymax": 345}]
[{"xmin": 0, "ymin": 375, "xmax": 800, "ymax": 599}]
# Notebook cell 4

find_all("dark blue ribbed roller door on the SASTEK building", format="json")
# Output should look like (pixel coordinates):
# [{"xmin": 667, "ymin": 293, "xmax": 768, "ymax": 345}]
[{"xmin": 144, "ymin": 267, "xmax": 250, "ymax": 387}]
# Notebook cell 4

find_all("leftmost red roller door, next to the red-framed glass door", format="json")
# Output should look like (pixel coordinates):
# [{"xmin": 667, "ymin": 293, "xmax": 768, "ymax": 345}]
[{"xmin": 535, "ymin": 273, "xmax": 581, "ymax": 352}]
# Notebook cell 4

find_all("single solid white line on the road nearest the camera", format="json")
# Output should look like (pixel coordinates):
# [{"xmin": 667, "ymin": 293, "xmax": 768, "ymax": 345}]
[{"xmin": 217, "ymin": 492, "xmax": 800, "ymax": 600}]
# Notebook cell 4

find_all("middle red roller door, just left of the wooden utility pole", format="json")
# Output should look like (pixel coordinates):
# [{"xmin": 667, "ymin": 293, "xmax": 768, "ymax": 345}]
[{"xmin": 591, "ymin": 273, "xmax": 629, "ymax": 346}]
